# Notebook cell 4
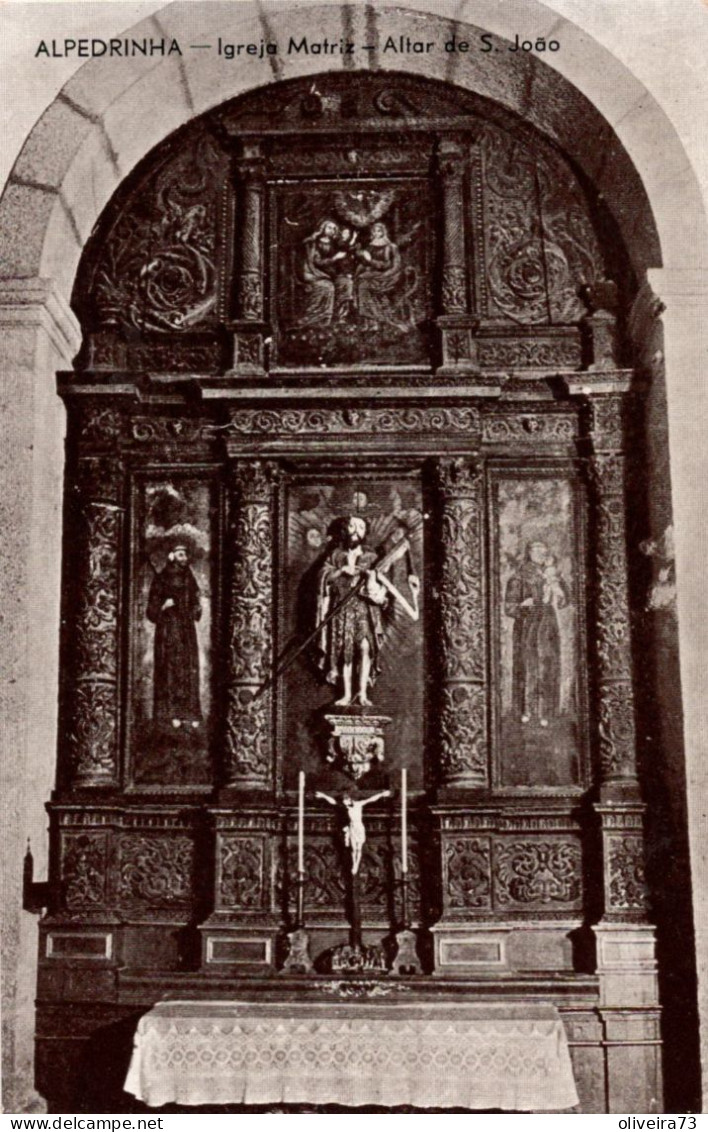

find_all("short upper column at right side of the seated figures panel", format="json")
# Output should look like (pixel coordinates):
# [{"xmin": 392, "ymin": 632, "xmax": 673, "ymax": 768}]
[{"xmin": 437, "ymin": 138, "xmax": 477, "ymax": 374}]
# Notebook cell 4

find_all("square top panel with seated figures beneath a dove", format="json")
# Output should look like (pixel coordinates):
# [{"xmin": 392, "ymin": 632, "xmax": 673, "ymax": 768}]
[{"xmin": 278, "ymin": 188, "xmax": 429, "ymax": 365}]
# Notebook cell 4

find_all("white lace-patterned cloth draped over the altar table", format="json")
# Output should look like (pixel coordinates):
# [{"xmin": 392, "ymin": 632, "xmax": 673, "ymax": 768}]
[{"xmin": 125, "ymin": 1001, "xmax": 578, "ymax": 1112}]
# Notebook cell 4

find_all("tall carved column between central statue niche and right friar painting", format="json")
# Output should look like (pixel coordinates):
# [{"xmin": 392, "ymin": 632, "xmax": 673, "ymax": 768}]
[{"xmin": 436, "ymin": 457, "xmax": 489, "ymax": 788}]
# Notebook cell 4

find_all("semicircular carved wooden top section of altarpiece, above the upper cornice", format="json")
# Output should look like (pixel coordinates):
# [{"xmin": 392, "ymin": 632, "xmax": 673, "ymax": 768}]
[{"xmin": 74, "ymin": 72, "xmax": 634, "ymax": 374}]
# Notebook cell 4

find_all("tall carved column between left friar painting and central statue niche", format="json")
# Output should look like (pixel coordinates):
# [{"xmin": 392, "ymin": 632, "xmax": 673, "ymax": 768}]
[{"xmin": 224, "ymin": 460, "xmax": 275, "ymax": 790}]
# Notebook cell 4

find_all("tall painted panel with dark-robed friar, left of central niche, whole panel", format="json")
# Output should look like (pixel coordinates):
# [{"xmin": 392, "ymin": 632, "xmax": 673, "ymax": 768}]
[{"xmin": 133, "ymin": 480, "xmax": 212, "ymax": 786}]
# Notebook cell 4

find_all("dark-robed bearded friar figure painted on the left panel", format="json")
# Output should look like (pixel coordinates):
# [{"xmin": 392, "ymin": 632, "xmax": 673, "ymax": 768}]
[{"xmin": 147, "ymin": 543, "xmax": 202, "ymax": 731}]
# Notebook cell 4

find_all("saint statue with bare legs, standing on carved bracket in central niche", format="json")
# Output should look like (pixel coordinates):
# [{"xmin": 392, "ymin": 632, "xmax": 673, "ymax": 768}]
[{"xmin": 317, "ymin": 515, "xmax": 420, "ymax": 708}]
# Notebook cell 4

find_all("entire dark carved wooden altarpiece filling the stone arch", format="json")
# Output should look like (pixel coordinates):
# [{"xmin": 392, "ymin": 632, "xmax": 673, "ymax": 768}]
[{"xmin": 39, "ymin": 72, "xmax": 659, "ymax": 1110}]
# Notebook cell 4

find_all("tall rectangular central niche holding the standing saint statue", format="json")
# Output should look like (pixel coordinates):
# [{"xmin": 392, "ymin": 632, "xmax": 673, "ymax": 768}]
[{"xmin": 279, "ymin": 473, "xmax": 426, "ymax": 789}]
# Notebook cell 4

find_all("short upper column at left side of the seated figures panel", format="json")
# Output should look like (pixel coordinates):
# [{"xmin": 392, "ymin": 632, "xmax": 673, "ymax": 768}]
[{"xmin": 233, "ymin": 142, "xmax": 265, "ymax": 375}]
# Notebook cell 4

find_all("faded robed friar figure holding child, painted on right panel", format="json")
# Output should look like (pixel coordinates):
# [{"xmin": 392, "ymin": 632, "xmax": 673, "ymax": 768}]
[{"xmin": 504, "ymin": 540, "xmax": 570, "ymax": 728}]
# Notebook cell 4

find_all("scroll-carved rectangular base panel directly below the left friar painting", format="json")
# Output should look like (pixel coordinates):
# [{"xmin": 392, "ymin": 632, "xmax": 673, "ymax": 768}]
[{"xmin": 118, "ymin": 833, "xmax": 195, "ymax": 908}]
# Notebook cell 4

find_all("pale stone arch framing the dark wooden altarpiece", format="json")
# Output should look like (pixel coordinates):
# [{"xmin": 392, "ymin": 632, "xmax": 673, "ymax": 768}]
[{"xmin": 0, "ymin": 0, "xmax": 706, "ymax": 1110}]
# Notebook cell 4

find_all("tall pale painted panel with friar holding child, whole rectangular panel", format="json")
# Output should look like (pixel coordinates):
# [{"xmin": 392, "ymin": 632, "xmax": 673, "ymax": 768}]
[{"xmin": 497, "ymin": 477, "xmax": 580, "ymax": 786}]
